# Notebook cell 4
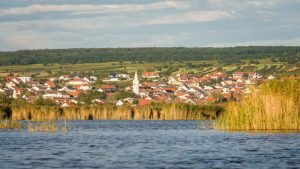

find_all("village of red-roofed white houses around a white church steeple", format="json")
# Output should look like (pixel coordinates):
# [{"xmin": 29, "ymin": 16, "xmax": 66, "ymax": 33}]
[{"xmin": 0, "ymin": 71, "xmax": 275, "ymax": 107}]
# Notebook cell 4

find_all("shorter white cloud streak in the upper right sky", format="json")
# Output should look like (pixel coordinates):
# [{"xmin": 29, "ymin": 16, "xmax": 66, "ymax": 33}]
[{"xmin": 145, "ymin": 11, "xmax": 235, "ymax": 25}]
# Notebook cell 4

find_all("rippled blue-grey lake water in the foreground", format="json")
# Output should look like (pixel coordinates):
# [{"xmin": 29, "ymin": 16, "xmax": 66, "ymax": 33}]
[{"xmin": 0, "ymin": 121, "xmax": 300, "ymax": 169}]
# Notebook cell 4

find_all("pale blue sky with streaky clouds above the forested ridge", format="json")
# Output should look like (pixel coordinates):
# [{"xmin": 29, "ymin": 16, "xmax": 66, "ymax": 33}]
[{"xmin": 0, "ymin": 0, "xmax": 300, "ymax": 51}]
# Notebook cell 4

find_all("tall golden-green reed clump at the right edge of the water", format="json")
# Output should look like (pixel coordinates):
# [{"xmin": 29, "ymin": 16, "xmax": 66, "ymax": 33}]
[{"xmin": 214, "ymin": 80, "xmax": 300, "ymax": 130}]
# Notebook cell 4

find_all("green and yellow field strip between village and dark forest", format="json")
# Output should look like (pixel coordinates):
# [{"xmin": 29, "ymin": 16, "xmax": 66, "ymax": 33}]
[{"xmin": 0, "ymin": 59, "xmax": 300, "ymax": 78}]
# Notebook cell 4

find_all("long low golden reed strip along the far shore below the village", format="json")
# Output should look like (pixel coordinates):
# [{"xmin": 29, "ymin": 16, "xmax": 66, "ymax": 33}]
[{"xmin": 7, "ymin": 103, "xmax": 222, "ymax": 121}]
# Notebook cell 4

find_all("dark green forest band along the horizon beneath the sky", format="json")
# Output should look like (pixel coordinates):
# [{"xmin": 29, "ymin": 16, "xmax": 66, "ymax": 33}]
[{"xmin": 0, "ymin": 46, "xmax": 300, "ymax": 65}]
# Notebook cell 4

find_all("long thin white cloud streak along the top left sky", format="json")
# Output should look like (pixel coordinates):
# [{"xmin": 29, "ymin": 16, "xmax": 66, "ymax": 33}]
[{"xmin": 0, "ymin": 1, "xmax": 190, "ymax": 16}]
